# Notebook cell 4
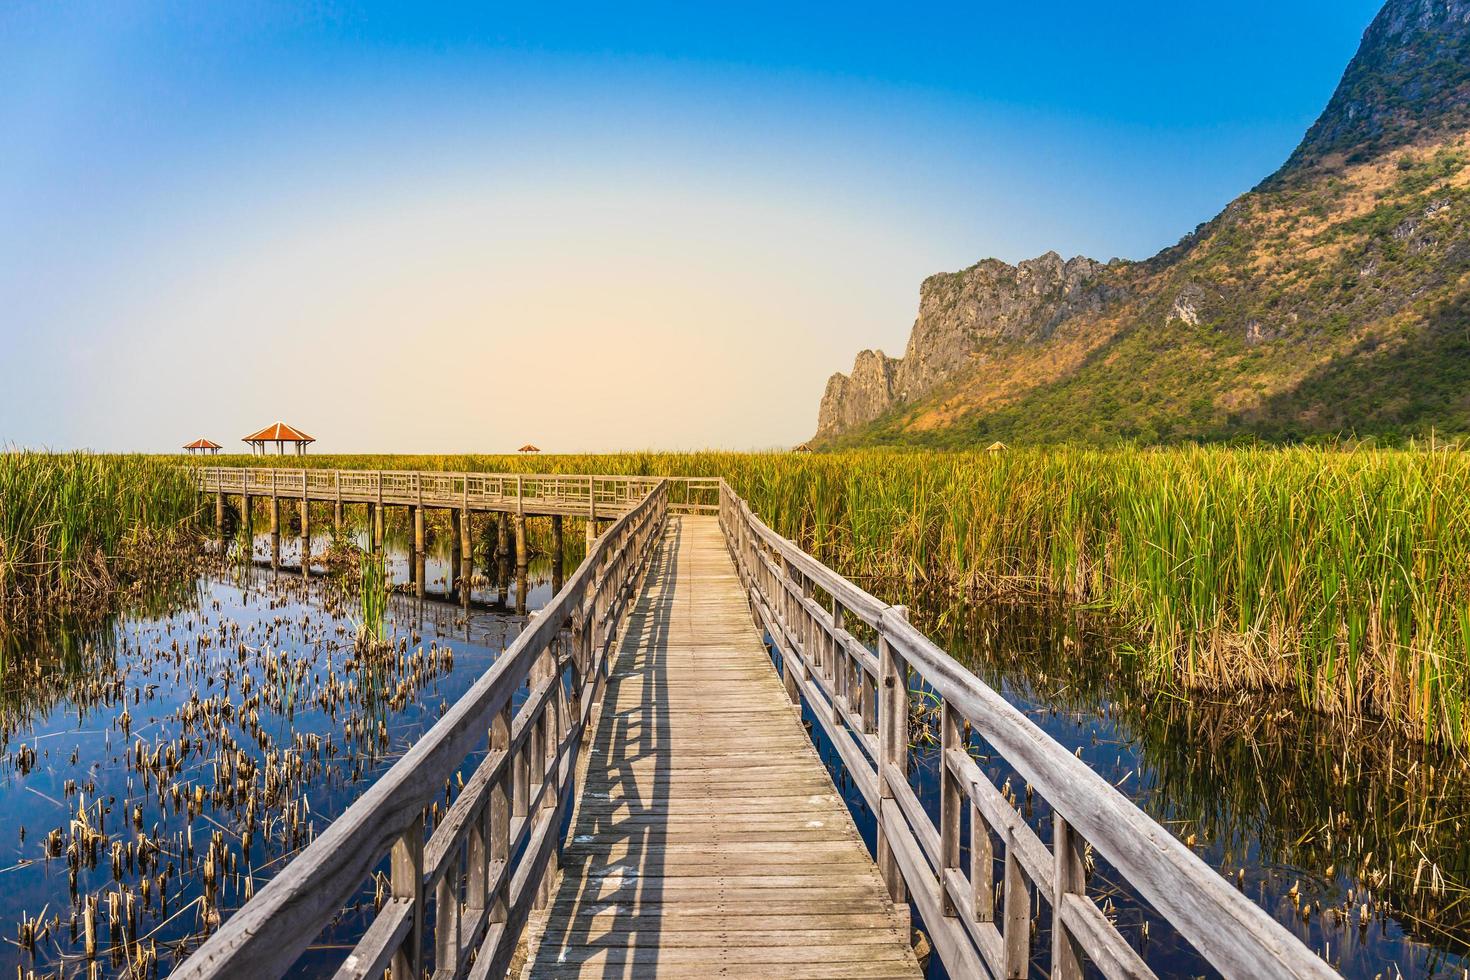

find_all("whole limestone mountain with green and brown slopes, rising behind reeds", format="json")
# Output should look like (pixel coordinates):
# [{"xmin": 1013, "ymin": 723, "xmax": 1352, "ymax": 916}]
[{"xmin": 817, "ymin": 0, "xmax": 1470, "ymax": 444}]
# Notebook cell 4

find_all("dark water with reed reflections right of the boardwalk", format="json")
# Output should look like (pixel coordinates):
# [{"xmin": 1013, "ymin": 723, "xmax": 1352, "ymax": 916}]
[{"xmin": 787, "ymin": 605, "xmax": 1470, "ymax": 979}]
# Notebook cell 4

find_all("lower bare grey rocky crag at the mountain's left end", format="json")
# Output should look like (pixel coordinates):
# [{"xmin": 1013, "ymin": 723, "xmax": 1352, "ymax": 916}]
[{"xmin": 817, "ymin": 251, "xmax": 1119, "ymax": 439}]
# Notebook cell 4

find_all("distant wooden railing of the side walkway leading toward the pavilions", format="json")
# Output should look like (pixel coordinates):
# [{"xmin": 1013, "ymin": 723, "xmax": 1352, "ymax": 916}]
[{"xmin": 194, "ymin": 466, "xmax": 720, "ymax": 520}]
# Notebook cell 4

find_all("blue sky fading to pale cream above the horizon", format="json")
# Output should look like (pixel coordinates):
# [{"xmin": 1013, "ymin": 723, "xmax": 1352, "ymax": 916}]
[{"xmin": 0, "ymin": 0, "xmax": 1377, "ymax": 451}]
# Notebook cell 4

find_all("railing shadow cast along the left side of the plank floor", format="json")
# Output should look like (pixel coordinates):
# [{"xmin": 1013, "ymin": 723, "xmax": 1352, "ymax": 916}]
[{"xmin": 531, "ymin": 517, "xmax": 684, "ymax": 977}]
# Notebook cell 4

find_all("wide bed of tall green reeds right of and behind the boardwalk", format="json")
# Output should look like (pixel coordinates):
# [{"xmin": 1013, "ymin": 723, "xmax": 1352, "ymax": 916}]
[{"xmin": 201, "ymin": 447, "xmax": 1470, "ymax": 745}]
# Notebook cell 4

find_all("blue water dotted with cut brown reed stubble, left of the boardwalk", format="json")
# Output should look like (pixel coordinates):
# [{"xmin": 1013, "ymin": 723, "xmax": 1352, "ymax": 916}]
[{"xmin": 0, "ymin": 536, "xmax": 560, "ymax": 977}]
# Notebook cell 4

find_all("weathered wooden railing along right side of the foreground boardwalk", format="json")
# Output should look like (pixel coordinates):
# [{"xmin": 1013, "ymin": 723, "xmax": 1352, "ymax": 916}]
[{"xmin": 720, "ymin": 486, "xmax": 1336, "ymax": 980}]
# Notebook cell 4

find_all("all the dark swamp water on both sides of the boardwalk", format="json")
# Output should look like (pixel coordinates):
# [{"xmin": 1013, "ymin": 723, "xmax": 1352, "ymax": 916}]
[{"xmin": 0, "ymin": 520, "xmax": 1470, "ymax": 977}]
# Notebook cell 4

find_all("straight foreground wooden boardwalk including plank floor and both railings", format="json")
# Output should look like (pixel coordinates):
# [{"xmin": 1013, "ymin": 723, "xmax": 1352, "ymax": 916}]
[{"xmin": 175, "ymin": 478, "xmax": 1336, "ymax": 980}]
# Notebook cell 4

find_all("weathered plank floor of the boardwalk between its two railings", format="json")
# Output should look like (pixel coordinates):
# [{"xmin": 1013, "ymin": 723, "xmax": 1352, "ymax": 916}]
[{"xmin": 523, "ymin": 516, "xmax": 919, "ymax": 977}]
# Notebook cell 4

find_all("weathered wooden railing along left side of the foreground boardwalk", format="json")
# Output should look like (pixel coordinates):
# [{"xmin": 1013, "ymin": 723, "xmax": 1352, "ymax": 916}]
[{"xmin": 172, "ymin": 481, "xmax": 669, "ymax": 980}]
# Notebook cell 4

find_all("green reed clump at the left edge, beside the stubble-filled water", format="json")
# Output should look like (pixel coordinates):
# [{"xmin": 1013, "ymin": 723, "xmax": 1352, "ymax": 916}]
[{"xmin": 0, "ymin": 450, "xmax": 198, "ymax": 621}]
